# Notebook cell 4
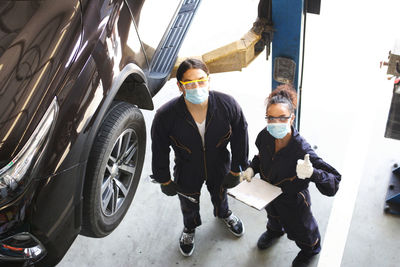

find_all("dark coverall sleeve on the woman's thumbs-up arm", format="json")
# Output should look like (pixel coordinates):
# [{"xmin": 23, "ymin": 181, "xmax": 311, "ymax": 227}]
[{"xmin": 307, "ymin": 148, "xmax": 342, "ymax": 196}]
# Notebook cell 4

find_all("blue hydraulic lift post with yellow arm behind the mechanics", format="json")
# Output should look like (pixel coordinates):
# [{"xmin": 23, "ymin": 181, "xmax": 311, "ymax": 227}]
[{"xmin": 170, "ymin": 0, "xmax": 321, "ymax": 129}]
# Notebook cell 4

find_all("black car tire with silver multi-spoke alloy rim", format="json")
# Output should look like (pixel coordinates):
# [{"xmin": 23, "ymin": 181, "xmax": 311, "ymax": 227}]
[{"xmin": 81, "ymin": 102, "xmax": 146, "ymax": 237}]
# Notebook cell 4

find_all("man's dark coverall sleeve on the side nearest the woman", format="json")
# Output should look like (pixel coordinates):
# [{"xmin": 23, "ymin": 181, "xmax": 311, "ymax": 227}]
[{"xmin": 230, "ymin": 98, "xmax": 249, "ymax": 172}]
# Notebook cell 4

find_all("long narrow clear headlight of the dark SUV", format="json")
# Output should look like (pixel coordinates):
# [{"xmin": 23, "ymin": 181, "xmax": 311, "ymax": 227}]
[{"xmin": 0, "ymin": 97, "xmax": 58, "ymax": 204}]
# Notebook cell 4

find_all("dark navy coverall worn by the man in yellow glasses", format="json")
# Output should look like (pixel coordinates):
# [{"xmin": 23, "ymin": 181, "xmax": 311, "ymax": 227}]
[{"xmin": 151, "ymin": 91, "xmax": 249, "ymax": 229}]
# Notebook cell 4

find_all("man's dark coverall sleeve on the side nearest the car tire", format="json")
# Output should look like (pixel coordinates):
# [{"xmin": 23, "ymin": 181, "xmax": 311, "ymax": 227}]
[{"xmin": 151, "ymin": 112, "xmax": 171, "ymax": 183}]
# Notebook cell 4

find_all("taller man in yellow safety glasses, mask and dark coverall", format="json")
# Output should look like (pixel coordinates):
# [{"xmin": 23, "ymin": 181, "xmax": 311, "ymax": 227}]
[{"xmin": 151, "ymin": 59, "xmax": 248, "ymax": 256}]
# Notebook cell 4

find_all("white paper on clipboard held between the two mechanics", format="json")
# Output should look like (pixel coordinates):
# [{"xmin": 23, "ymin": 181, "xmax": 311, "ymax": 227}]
[{"xmin": 228, "ymin": 177, "xmax": 282, "ymax": 210}]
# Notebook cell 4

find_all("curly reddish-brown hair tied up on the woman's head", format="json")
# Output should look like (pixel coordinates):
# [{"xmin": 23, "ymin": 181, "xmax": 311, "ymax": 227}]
[{"xmin": 265, "ymin": 84, "xmax": 297, "ymax": 113}]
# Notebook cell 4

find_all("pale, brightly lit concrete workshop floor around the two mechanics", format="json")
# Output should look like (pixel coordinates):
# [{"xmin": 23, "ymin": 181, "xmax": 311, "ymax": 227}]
[{"xmin": 58, "ymin": 0, "xmax": 400, "ymax": 267}]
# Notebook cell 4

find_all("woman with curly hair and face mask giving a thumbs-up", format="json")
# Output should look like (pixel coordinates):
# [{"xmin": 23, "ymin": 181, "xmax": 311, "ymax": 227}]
[{"xmin": 239, "ymin": 85, "xmax": 341, "ymax": 266}]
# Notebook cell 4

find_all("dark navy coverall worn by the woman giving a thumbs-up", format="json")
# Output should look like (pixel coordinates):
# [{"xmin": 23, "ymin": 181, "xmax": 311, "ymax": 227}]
[{"xmin": 250, "ymin": 127, "xmax": 341, "ymax": 254}]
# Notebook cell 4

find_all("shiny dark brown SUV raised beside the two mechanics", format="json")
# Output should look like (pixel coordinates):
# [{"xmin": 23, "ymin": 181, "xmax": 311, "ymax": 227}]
[{"xmin": 0, "ymin": 0, "xmax": 200, "ymax": 266}]
